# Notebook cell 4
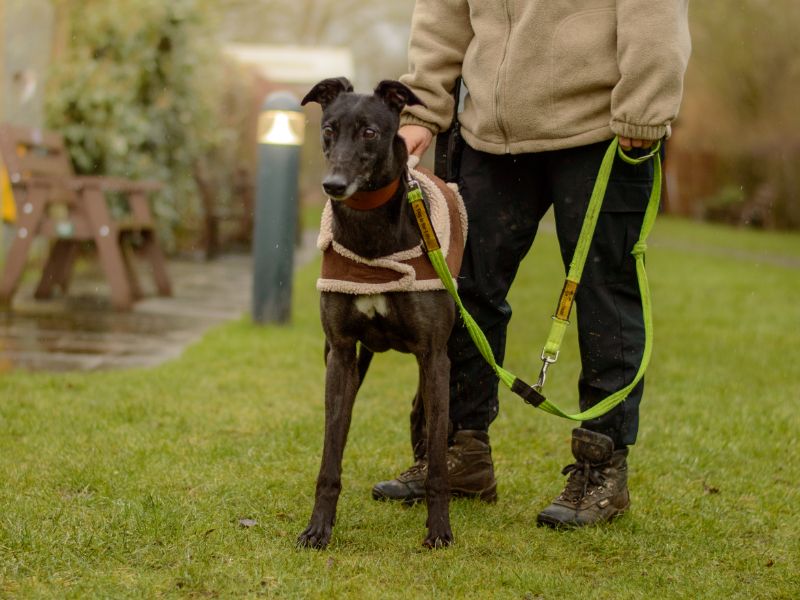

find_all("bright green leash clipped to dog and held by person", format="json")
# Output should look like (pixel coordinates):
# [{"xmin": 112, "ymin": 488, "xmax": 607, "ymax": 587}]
[{"xmin": 408, "ymin": 138, "xmax": 661, "ymax": 421}]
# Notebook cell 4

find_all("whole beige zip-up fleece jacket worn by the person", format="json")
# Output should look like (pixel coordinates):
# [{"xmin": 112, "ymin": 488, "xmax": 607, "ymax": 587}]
[{"xmin": 401, "ymin": 0, "xmax": 691, "ymax": 154}]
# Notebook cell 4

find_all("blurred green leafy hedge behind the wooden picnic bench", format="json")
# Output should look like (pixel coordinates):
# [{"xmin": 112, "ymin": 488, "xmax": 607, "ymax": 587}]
[{"xmin": 46, "ymin": 0, "xmax": 230, "ymax": 248}]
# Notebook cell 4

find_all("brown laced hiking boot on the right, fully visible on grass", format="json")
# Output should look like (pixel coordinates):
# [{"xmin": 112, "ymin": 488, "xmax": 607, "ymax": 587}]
[{"xmin": 536, "ymin": 429, "xmax": 630, "ymax": 527}]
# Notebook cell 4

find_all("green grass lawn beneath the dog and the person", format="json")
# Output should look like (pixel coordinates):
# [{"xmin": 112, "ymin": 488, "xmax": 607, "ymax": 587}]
[{"xmin": 0, "ymin": 214, "xmax": 800, "ymax": 599}]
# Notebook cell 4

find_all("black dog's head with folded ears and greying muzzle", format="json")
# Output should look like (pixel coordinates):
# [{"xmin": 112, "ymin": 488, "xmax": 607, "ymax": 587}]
[{"xmin": 302, "ymin": 77, "xmax": 422, "ymax": 200}]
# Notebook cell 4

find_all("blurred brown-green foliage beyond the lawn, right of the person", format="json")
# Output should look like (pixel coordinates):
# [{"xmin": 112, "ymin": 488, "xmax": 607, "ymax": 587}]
[{"xmin": 667, "ymin": 0, "xmax": 800, "ymax": 229}]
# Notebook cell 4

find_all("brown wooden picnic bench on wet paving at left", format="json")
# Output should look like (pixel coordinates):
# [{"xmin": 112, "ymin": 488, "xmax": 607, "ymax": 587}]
[{"xmin": 0, "ymin": 124, "xmax": 172, "ymax": 310}]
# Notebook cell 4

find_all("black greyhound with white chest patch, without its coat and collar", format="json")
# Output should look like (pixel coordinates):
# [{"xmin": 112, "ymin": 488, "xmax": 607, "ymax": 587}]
[{"xmin": 297, "ymin": 78, "xmax": 455, "ymax": 548}]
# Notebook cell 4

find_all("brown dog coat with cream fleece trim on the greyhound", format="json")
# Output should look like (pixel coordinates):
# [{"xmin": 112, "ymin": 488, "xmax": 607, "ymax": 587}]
[{"xmin": 317, "ymin": 157, "xmax": 467, "ymax": 294}]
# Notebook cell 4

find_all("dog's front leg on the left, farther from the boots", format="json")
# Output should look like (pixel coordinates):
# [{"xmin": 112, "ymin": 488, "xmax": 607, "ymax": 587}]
[{"xmin": 297, "ymin": 342, "xmax": 358, "ymax": 548}]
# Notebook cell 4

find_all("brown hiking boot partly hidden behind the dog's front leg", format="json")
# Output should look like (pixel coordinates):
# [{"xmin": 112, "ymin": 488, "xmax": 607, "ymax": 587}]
[{"xmin": 372, "ymin": 429, "xmax": 497, "ymax": 504}]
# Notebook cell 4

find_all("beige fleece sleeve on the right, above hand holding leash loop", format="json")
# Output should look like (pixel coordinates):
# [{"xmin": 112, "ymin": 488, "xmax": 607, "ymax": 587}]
[{"xmin": 611, "ymin": 0, "xmax": 691, "ymax": 140}]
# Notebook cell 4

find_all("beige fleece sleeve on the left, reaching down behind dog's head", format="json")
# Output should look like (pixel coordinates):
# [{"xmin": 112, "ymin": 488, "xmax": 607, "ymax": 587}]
[{"xmin": 400, "ymin": 0, "xmax": 473, "ymax": 135}]
